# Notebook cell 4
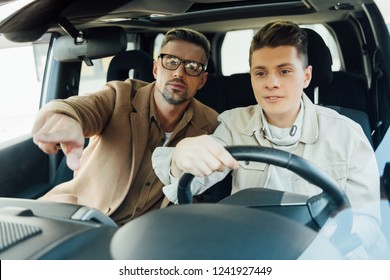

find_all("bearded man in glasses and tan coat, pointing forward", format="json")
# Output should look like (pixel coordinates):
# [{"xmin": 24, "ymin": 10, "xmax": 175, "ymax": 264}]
[{"xmin": 32, "ymin": 28, "xmax": 218, "ymax": 225}]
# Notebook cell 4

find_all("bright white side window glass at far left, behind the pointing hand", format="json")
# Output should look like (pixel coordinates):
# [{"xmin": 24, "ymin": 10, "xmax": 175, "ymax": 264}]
[{"xmin": 0, "ymin": 35, "xmax": 49, "ymax": 144}]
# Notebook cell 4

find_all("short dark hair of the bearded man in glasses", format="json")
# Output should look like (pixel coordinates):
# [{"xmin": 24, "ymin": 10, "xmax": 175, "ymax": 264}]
[{"xmin": 161, "ymin": 27, "xmax": 211, "ymax": 63}]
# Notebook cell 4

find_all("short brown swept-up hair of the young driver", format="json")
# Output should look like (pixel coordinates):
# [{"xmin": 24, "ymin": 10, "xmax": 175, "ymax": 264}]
[{"xmin": 249, "ymin": 20, "xmax": 308, "ymax": 67}]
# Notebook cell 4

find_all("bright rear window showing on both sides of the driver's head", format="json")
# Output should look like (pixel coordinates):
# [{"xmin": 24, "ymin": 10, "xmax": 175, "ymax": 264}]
[{"xmin": 221, "ymin": 24, "xmax": 341, "ymax": 76}]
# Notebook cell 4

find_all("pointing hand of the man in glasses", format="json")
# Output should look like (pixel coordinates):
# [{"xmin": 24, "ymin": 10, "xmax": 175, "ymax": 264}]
[{"xmin": 31, "ymin": 111, "xmax": 85, "ymax": 170}]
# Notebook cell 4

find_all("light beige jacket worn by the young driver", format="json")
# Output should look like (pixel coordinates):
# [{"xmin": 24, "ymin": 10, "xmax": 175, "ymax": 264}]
[{"xmin": 153, "ymin": 94, "xmax": 380, "ymax": 255}]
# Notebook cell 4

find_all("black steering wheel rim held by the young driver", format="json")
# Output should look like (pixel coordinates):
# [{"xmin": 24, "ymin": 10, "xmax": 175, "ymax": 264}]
[{"xmin": 178, "ymin": 146, "xmax": 352, "ymax": 242}]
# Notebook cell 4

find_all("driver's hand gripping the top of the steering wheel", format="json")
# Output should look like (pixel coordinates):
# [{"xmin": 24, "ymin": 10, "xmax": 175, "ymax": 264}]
[{"xmin": 171, "ymin": 135, "xmax": 239, "ymax": 177}]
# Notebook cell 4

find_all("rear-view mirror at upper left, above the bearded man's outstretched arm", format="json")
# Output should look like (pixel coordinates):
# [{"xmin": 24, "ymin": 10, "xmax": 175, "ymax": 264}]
[{"xmin": 54, "ymin": 26, "xmax": 127, "ymax": 65}]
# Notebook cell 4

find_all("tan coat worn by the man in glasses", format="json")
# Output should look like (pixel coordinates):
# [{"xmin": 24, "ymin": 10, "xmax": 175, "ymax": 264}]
[{"xmin": 41, "ymin": 80, "xmax": 218, "ymax": 215}]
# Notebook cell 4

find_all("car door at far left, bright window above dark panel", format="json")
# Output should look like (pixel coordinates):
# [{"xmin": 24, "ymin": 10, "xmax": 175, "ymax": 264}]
[{"xmin": 0, "ymin": 35, "xmax": 54, "ymax": 197}]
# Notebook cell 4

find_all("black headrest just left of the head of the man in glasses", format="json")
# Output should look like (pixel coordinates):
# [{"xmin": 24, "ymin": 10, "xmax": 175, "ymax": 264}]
[{"xmin": 107, "ymin": 50, "xmax": 154, "ymax": 82}]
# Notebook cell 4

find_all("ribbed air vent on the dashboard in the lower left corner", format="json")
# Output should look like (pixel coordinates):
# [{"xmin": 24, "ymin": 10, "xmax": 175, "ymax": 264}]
[{"xmin": 0, "ymin": 221, "xmax": 42, "ymax": 252}]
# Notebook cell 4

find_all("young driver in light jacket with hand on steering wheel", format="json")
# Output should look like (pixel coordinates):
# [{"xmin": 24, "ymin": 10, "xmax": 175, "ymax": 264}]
[{"xmin": 153, "ymin": 21, "xmax": 380, "ymax": 257}]
